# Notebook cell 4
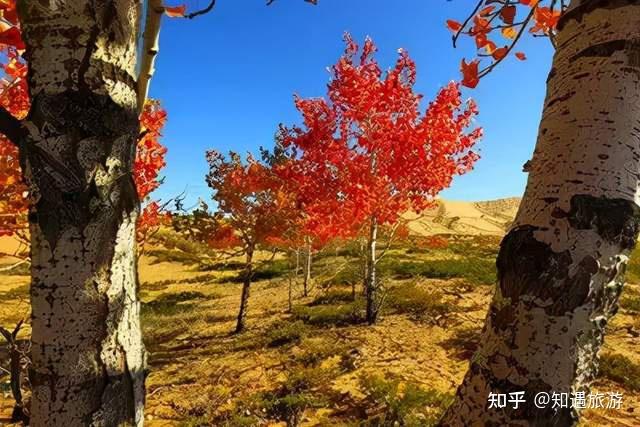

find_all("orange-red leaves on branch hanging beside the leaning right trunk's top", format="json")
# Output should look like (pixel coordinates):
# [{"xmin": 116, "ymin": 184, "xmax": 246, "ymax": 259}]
[{"xmin": 447, "ymin": 0, "xmax": 565, "ymax": 88}]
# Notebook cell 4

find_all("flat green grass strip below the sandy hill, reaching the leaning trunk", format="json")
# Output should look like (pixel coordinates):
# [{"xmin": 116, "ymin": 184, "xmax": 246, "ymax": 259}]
[{"xmin": 379, "ymin": 256, "xmax": 496, "ymax": 285}]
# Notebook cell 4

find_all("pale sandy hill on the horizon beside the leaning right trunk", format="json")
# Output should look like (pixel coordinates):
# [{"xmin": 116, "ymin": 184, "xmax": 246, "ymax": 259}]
[{"xmin": 405, "ymin": 197, "xmax": 520, "ymax": 236}]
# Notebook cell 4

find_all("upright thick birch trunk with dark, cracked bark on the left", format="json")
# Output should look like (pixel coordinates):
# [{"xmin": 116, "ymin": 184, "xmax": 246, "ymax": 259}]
[{"xmin": 18, "ymin": 0, "xmax": 145, "ymax": 427}]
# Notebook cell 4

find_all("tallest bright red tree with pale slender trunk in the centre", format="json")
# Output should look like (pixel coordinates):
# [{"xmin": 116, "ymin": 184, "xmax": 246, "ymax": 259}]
[{"xmin": 280, "ymin": 35, "xmax": 482, "ymax": 323}]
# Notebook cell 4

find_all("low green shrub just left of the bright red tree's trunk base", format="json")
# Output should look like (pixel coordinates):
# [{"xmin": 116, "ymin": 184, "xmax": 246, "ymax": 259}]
[{"xmin": 293, "ymin": 300, "xmax": 364, "ymax": 326}]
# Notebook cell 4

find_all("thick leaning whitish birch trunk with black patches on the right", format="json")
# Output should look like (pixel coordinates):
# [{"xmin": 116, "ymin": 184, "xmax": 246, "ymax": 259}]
[{"xmin": 441, "ymin": 0, "xmax": 640, "ymax": 426}]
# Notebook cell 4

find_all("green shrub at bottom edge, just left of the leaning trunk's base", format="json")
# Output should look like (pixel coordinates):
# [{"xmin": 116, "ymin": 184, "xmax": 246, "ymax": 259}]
[{"xmin": 360, "ymin": 375, "xmax": 453, "ymax": 427}]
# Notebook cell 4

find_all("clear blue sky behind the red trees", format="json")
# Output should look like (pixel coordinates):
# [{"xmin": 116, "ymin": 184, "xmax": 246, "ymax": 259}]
[{"xmin": 151, "ymin": 0, "xmax": 552, "ymax": 205}]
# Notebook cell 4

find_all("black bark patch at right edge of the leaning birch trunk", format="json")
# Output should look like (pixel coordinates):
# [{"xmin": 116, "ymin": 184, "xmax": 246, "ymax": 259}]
[{"xmin": 568, "ymin": 194, "xmax": 640, "ymax": 250}]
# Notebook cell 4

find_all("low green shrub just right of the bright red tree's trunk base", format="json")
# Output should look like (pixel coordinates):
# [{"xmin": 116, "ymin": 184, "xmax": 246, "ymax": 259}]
[{"xmin": 385, "ymin": 285, "xmax": 456, "ymax": 323}]
